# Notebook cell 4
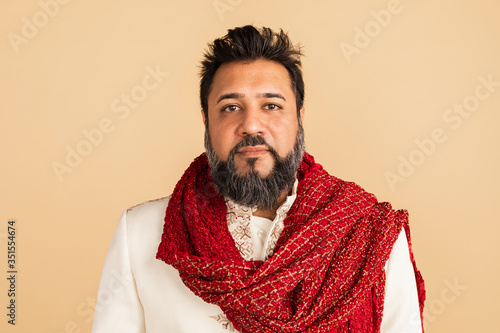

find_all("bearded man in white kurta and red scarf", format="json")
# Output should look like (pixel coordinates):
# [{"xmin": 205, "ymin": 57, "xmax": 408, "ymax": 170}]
[{"xmin": 93, "ymin": 26, "xmax": 424, "ymax": 333}]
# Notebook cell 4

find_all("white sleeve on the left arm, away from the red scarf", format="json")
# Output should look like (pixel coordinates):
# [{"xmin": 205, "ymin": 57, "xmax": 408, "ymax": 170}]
[{"xmin": 92, "ymin": 211, "xmax": 146, "ymax": 333}]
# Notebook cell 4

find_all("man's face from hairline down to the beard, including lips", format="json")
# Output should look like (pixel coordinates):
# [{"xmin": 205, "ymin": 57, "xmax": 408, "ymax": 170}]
[{"xmin": 204, "ymin": 60, "xmax": 304, "ymax": 178}]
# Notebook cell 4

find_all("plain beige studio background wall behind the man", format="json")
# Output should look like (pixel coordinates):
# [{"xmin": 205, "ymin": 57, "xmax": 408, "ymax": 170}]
[{"xmin": 0, "ymin": 0, "xmax": 500, "ymax": 333}]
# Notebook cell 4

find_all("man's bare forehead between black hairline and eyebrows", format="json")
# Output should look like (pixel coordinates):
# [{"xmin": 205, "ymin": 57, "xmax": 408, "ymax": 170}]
[{"xmin": 208, "ymin": 59, "xmax": 295, "ymax": 102}]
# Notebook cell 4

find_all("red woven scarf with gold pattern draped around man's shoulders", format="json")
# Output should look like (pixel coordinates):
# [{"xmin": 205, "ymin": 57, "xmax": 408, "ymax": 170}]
[{"xmin": 156, "ymin": 153, "xmax": 424, "ymax": 333}]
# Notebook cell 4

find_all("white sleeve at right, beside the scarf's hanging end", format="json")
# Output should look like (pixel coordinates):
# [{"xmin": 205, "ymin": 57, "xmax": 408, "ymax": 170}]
[{"xmin": 380, "ymin": 229, "xmax": 422, "ymax": 333}]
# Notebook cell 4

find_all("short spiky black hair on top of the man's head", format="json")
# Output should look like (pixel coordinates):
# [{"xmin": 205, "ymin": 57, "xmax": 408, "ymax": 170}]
[{"xmin": 200, "ymin": 25, "xmax": 304, "ymax": 123}]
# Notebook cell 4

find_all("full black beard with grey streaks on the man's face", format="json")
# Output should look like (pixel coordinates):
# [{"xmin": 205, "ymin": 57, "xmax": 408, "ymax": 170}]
[{"xmin": 205, "ymin": 123, "xmax": 305, "ymax": 210}]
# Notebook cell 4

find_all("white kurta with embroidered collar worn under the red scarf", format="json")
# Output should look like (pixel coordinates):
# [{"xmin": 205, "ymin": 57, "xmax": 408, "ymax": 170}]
[{"xmin": 92, "ymin": 196, "xmax": 421, "ymax": 333}]
